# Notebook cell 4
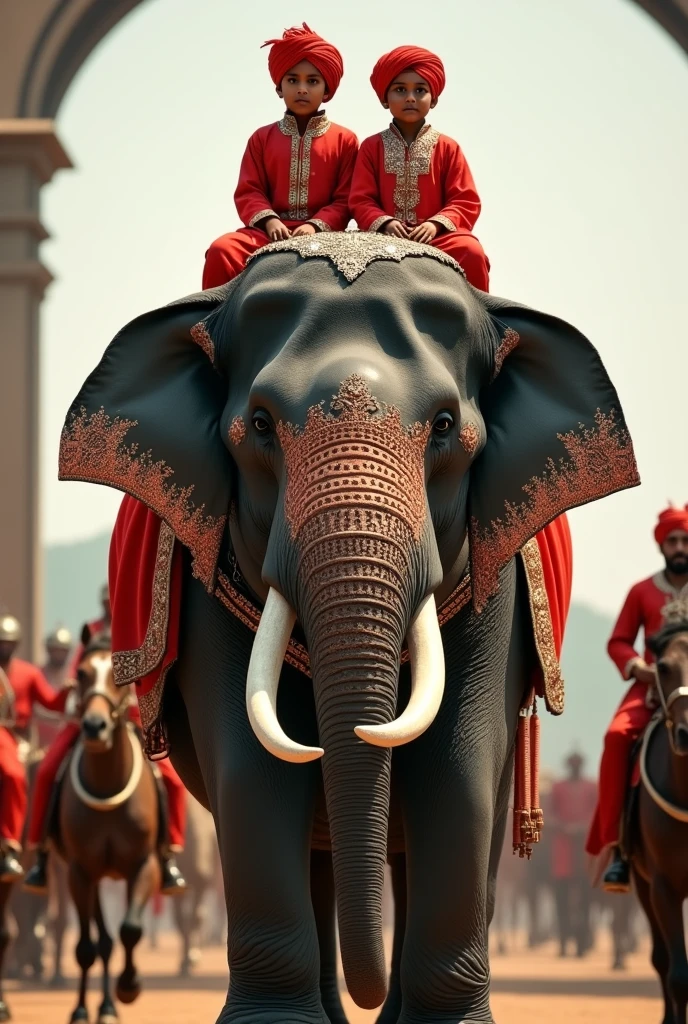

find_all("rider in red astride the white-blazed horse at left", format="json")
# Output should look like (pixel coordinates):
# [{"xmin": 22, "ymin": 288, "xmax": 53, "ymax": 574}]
[{"xmin": 24, "ymin": 584, "xmax": 186, "ymax": 896}]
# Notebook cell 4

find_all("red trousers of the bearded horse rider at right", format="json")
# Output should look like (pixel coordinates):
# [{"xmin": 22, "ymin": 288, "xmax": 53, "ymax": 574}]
[{"xmin": 586, "ymin": 682, "xmax": 652, "ymax": 857}]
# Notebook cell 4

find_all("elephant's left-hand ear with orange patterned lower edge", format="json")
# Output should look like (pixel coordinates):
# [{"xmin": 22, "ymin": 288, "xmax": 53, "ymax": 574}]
[{"xmin": 59, "ymin": 283, "xmax": 234, "ymax": 590}]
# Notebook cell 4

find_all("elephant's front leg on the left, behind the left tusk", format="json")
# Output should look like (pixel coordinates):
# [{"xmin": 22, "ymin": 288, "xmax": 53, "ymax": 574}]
[{"xmin": 176, "ymin": 580, "xmax": 327, "ymax": 1024}]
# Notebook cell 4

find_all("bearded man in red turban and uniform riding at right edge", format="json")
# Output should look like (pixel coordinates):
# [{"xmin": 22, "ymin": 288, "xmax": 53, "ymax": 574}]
[{"xmin": 586, "ymin": 506, "xmax": 688, "ymax": 892}]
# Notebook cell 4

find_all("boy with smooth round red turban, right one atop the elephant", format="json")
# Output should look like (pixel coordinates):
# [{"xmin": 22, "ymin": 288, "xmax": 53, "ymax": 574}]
[{"xmin": 349, "ymin": 46, "xmax": 489, "ymax": 292}]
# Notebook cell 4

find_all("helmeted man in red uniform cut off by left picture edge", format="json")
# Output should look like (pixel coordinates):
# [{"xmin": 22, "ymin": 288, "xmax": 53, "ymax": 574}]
[{"xmin": 0, "ymin": 615, "xmax": 71, "ymax": 882}]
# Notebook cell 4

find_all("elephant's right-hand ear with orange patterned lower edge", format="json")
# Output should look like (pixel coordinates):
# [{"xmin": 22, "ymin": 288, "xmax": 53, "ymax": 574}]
[{"xmin": 469, "ymin": 295, "xmax": 640, "ymax": 610}]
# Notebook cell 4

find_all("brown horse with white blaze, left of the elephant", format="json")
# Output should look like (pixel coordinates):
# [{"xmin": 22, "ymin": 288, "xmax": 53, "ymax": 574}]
[{"xmin": 54, "ymin": 629, "xmax": 160, "ymax": 1024}]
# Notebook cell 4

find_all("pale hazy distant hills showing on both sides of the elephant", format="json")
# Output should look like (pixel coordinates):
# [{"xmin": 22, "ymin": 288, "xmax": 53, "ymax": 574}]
[{"xmin": 44, "ymin": 532, "xmax": 624, "ymax": 774}]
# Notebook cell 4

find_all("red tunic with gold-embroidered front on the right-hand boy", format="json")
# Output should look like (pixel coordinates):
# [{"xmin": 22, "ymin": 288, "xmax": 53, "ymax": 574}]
[{"xmin": 349, "ymin": 124, "xmax": 480, "ymax": 234}]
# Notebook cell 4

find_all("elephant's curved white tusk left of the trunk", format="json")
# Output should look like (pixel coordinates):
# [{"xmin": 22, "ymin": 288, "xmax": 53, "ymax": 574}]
[{"xmin": 246, "ymin": 588, "xmax": 325, "ymax": 764}]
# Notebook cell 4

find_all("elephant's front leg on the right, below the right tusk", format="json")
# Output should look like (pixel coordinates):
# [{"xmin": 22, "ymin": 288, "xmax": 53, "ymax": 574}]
[{"xmin": 393, "ymin": 563, "xmax": 532, "ymax": 1024}]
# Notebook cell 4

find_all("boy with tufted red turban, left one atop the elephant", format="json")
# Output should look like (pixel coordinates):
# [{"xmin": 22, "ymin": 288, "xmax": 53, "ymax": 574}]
[{"xmin": 203, "ymin": 23, "xmax": 358, "ymax": 289}]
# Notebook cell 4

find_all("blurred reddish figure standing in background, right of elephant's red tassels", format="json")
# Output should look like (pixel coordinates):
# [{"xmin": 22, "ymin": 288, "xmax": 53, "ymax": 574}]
[{"xmin": 548, "ymin": 751, "xmax": 597, "ymax": 956}]
